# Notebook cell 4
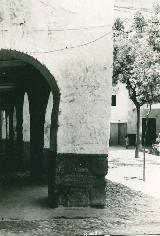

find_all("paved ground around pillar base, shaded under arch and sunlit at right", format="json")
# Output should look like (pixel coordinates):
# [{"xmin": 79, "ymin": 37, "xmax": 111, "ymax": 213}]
[{"xmin": 0, "ymin": 150, "xmax": 160, "ymax": 236}]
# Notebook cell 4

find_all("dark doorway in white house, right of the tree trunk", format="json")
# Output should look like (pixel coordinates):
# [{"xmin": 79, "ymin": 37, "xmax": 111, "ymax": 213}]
[{"xmin": 142, "ymin": 118, "xmax": 156, "ymax": 146}]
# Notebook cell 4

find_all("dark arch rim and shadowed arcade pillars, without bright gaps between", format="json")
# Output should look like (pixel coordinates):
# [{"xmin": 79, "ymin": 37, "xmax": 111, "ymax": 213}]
[{"xmin": 0, "ymin": 49, "xmax": 60, "ymax": 181}]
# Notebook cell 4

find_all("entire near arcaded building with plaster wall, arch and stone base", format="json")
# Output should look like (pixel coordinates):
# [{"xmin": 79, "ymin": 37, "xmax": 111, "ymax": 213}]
[{"xmin": 0, "ymin": 0, "xmax": 113, "ymax": 206}]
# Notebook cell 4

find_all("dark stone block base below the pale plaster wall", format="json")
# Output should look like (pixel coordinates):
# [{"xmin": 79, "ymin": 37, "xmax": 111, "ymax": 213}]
[{"xmin": 48, "ymin": 154, "xmax": 108, "ymax": 207}]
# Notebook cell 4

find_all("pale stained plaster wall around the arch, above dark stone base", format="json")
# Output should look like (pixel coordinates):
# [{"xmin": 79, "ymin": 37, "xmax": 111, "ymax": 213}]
[{"xmin": 0, "ymin": 0, "xmax": 113, "ymax": 154}]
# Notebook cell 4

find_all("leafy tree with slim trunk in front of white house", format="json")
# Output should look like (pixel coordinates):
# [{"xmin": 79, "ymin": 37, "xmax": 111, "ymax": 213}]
[{"xmin": 113, "ymin": 21, "xmax": 160, "ymax": 158}]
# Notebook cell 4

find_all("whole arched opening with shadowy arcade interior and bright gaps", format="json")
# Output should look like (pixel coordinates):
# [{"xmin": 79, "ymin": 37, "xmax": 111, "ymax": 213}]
[{"xmin": 0, "ymin": 50, "xmax": 60, "ymax": 183}]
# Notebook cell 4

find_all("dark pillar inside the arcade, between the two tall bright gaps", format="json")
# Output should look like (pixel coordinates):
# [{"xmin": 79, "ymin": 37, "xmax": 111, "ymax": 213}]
[{"xmin": 27, "ymin": 80, "xmax": 50, "ymax": 180}]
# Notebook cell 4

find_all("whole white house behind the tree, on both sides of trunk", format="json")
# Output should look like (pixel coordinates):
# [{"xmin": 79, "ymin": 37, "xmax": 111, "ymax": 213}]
[{"xmin": 110, "ymin": 83, "xmax": 160, "ymax": 146}]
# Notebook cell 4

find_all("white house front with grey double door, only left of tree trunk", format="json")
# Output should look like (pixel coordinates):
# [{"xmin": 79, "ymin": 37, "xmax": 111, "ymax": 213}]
[{"xmin": 110, "ymin": 83, "xmax": 136, "ymax": 146}]
